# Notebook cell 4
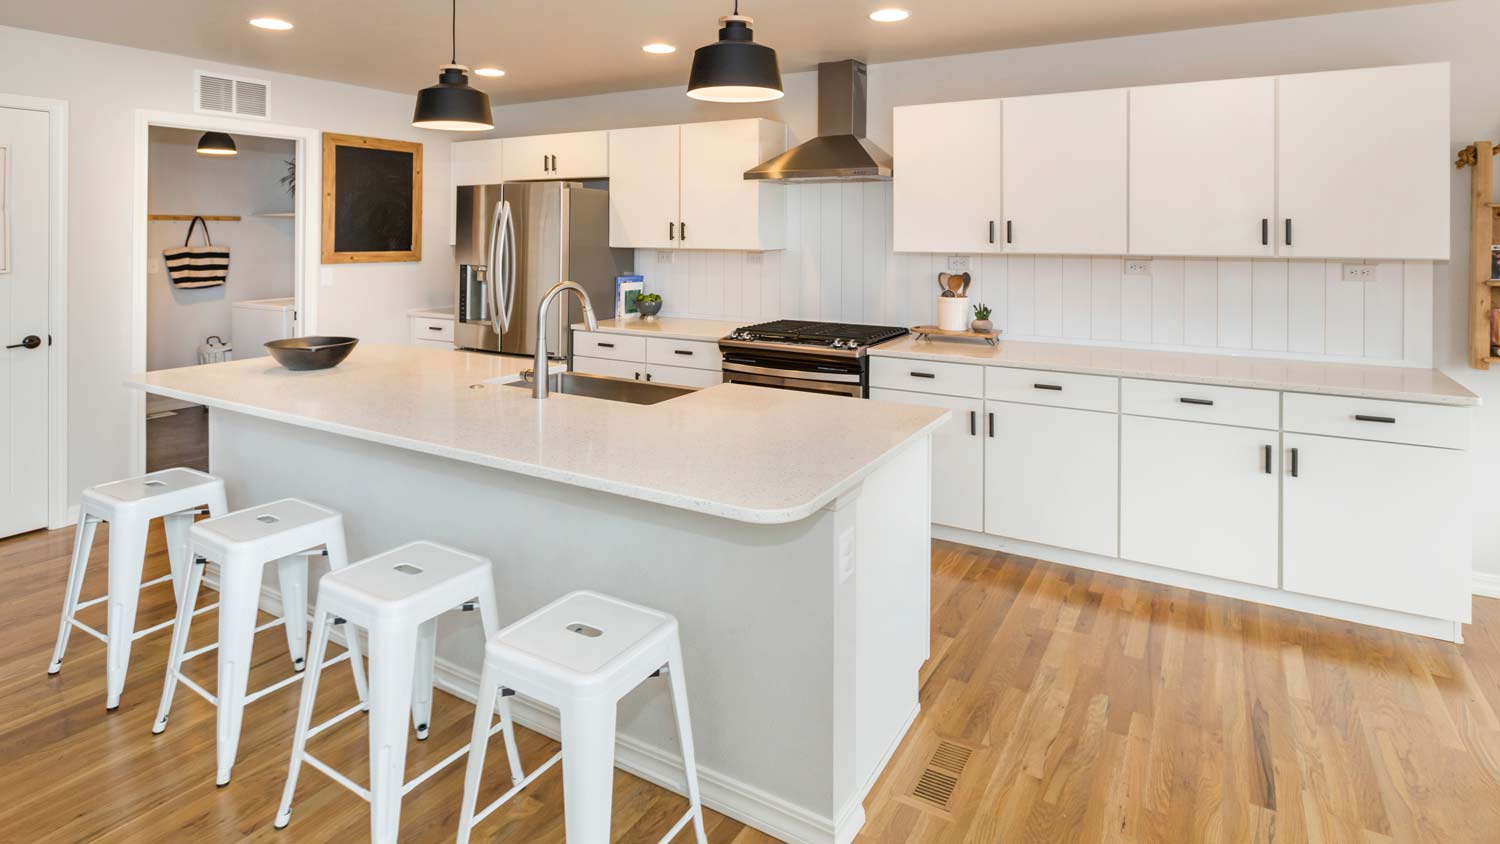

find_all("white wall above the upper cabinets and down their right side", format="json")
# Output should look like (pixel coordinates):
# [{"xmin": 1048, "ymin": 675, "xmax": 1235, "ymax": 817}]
[{"xmin": 495, "ymin": 0, "xmax": 1500, "ymax": 574}]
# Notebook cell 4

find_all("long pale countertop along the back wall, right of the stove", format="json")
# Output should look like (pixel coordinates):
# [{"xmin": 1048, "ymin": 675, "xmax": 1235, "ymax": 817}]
[{"xmin": 870, "ymin": 336, "xmax": 1479, "ymax": 405}]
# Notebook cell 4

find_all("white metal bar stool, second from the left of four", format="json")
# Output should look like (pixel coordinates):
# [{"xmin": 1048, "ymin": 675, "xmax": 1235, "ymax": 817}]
[{"xmin": 152, "ymin": 498, "xmax": 366, "ymax": 786}]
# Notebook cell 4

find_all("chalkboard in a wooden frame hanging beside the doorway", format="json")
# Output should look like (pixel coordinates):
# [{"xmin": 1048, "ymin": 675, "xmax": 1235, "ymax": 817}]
[{"xmin": 323, "ymin": 132, "xmax": 422, "ymax": 264}]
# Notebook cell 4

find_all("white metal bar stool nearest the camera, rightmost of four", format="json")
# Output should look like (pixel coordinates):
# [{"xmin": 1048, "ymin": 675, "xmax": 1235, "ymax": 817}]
[{"xmin": 459, "ymin": 592, "xmax": 708, "ymax": 844}]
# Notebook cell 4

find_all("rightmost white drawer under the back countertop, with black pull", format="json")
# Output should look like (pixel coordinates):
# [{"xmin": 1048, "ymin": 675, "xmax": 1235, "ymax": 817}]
[{"xmin": 1281, "ymin": 393, "xmax": 1470, "ymax": 448}]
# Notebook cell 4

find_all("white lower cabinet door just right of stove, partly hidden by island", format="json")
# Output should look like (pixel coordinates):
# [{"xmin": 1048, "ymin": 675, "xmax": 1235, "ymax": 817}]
[{"xmin": 870, "ymin": 390, "xmax": 984, "ymax": 531}]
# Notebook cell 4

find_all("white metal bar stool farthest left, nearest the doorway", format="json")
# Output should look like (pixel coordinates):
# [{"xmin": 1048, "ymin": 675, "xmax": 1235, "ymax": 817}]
[{"xmin": 47, "ymin": 469, "xmax": 228, "ymax": 711}]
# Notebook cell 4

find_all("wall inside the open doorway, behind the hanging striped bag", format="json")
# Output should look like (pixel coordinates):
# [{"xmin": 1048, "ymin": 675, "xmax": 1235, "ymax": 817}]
[{"xmin": 146, "ymin": 129, "xmax": 296, "ymax": 369}]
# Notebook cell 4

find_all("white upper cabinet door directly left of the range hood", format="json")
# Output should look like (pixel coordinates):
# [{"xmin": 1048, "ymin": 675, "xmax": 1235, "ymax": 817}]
[{"xmin": 677, "ymin": 120, "xmax": 786, "ymax": 250}]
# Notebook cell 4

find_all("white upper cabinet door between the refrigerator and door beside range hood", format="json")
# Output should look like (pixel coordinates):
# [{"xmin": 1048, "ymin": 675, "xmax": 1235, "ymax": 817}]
[{"xmin": 609, "ymin": 126, "xmax": 680, "ymax": 249}]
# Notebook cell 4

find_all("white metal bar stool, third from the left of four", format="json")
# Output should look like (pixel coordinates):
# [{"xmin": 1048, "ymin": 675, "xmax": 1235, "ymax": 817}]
[{"xmin": 276, "ymin": 543, "xmax": 521, "ymax": 844}]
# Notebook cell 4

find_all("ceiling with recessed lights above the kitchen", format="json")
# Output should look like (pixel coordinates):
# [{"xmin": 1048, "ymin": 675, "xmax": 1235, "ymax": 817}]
[{"xmin": 0, "ymin": 0, "xmax": 1437, "ymax": 105}]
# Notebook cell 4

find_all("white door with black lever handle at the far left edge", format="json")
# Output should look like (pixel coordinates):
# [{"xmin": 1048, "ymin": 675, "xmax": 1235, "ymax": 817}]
[{"xmin": 0, "ymin": 108, "xmax": 51, "ymax": 537}]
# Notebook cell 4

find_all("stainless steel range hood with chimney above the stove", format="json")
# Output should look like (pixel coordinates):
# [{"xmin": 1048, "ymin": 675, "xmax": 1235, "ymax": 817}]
[{"xmin": 746, "ymin": 58, "xmax": 891, "ymax": 183}]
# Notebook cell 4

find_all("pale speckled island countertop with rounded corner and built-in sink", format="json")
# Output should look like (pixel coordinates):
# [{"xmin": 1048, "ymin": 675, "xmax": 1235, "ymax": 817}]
[{"xmin": 126, "ymin": 345, "xmax": 948, "ymax": 523}]
